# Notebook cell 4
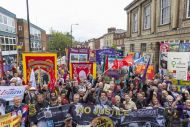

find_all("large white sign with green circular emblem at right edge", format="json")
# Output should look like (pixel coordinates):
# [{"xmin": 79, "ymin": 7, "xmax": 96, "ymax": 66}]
[{"xmin": 168, "ymin": 52, "xmax": 190, "ymax": 80}]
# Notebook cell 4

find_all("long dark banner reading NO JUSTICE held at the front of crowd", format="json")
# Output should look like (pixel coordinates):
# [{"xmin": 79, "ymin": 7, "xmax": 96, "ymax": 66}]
[{"xmin": 37, "ymin": 103, "xmax": 165, "ymax": 127}]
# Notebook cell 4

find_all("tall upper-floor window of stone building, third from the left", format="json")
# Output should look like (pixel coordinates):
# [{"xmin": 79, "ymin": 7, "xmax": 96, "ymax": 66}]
[{"xmin": 160, "ymin": 0, "xmax": 170, "ymax": 25}]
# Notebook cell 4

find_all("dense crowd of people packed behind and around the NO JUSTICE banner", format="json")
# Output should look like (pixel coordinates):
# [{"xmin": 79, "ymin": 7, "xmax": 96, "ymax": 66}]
[{"xmin": 0, "ymin": 67, "xmax": 190, "ymax": 127}]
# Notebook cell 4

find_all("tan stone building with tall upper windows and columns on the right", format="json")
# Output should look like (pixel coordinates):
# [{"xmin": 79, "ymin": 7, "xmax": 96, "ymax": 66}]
[{"xmin": 125, "ymin": 0, "xmax": 190, "ymax": 69}]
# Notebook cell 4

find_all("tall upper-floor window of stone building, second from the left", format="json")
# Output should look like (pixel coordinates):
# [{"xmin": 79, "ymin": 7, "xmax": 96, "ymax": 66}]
[{"xmin": 144, "ymin": 5, "xmax": 150, "ymax": 29}]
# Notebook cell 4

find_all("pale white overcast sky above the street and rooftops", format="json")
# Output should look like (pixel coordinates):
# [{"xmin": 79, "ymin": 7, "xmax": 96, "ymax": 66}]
[{"xmin": 0, "ymin": 0, "xmax": 133, "ymax": 42}]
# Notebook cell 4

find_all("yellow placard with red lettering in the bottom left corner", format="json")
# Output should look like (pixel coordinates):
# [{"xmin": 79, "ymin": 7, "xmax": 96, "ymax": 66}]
[{"xmin": 0, "ymin": 113, "xmax": 21, "ymax": 127}]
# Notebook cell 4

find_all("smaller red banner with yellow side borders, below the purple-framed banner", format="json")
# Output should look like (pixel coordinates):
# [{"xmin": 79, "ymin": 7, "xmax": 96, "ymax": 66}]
[{"xmin": 70, "ymin": 63, "xmax": 96, "ymax": 81}]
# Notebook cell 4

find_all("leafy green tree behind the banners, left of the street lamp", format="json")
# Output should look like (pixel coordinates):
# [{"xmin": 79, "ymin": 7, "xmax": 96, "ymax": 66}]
[{"xmin": 48, "ymin": 30, "xmax": 71, "ymax": 56}]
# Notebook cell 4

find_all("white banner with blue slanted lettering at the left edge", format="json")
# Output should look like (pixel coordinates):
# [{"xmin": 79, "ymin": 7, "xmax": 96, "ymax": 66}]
[{"xmin": 0, "ymin": 86, "xmax": 25, "ymax": 101}]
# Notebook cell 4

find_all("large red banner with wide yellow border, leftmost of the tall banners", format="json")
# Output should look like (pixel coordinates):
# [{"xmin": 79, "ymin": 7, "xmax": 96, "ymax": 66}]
[{"xmin": 22, "ymin": 53, "xmax": 57, "ymax": 84}]
